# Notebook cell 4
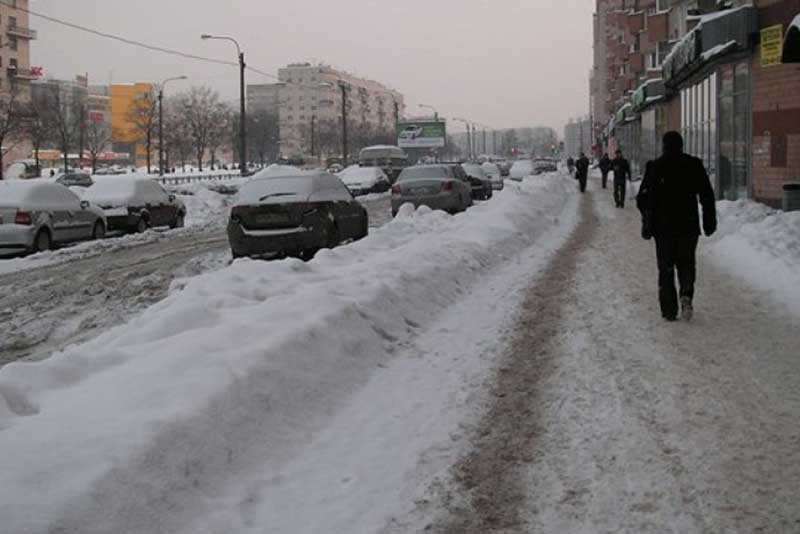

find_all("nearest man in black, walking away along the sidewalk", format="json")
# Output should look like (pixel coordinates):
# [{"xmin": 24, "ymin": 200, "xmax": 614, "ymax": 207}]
[{"xmin": 636, "ymin": 132, "xmax": 717, "ymax": 321}]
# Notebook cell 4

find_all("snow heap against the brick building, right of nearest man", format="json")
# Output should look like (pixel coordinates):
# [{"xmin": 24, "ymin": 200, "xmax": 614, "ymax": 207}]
[{"xmin": 707, "ymin": 200, "xmax": 800, "ymax": 315}]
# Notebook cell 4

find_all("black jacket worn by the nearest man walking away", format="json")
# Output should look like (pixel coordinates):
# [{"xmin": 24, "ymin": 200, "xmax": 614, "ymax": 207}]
[{"xmin": 636, "ymin": 153, "xmax": 717, "ymax": 239}]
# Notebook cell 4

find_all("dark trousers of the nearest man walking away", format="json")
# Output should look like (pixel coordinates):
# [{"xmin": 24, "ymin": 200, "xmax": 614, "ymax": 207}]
[{"xmin": 656, "ymin": 235, "xmax": 699, "ymax": 318}]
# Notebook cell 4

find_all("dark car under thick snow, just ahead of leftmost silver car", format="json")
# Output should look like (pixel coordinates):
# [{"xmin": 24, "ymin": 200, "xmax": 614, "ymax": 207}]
[{"xmin": 83, "ymin": 176, "xmax": 186, "ymax": 233}]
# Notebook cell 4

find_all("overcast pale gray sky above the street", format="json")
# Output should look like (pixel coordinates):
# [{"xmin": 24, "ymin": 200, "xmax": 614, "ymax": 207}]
[{"xmin": 31, "ymin": 0, "xmax": 593, "ymax": 132}]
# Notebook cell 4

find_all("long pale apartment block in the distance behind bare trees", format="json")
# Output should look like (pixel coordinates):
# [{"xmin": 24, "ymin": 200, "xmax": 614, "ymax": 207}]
[{"xmin": 247, "ymin": 63, "xmax": 405, "ymax": 157}]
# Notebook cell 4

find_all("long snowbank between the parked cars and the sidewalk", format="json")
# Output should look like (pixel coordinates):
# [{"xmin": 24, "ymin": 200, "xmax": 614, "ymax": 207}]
[{"xmin": 0, "ymin": 175, "xmax": 574, "ymax": 534}]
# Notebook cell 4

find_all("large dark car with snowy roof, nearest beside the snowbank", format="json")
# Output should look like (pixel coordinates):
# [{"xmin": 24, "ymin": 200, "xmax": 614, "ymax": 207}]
[{"xmin": 228, "ymin": 171, "xmax": 369, "ymax": 258}]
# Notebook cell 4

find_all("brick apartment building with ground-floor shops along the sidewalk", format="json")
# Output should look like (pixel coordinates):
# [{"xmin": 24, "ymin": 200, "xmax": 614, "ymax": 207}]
[{"xmin": 591, "ymin": 0, "xmax": 800, "ymax": 205}]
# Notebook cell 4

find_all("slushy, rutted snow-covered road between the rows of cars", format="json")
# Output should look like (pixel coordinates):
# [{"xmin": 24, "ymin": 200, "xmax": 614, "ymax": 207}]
[{"xmin": 0, "ymin": 193, "xmax": 391, "ymax": 367}]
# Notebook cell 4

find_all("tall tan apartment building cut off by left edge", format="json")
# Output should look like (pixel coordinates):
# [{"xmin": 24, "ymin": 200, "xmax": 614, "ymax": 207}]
[{"xmin": 0, "ymin": 0, "xmax": 41, "ymax": 170}]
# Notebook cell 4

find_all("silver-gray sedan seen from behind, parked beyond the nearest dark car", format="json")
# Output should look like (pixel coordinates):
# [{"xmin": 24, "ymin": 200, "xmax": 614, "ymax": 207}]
[{"xmin": 392, "ymin": 165, "xmax": 472, "ymax": 219}]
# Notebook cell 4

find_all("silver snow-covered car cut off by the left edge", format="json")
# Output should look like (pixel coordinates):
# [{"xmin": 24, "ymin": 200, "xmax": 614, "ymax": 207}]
[{"xmin": 0, "ymin": 179, "xmax": 106, "ymax": 253}]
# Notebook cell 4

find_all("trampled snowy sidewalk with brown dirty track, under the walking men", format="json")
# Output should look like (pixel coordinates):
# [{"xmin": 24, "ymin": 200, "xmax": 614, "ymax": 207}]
[{"xmin": 432, "ymin": 183, "xmax": 800, "ymax": 534}]
